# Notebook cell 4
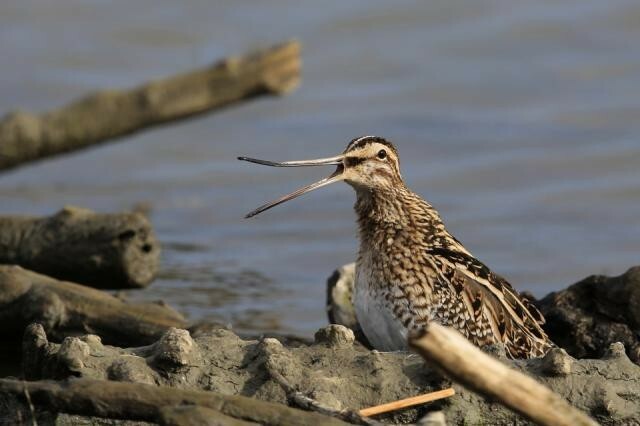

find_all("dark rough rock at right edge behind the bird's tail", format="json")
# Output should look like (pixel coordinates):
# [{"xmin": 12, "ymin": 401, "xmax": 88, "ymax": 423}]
[{"xmin": 537, "ymin": 266, "xmax": 640, "ymax": 363}]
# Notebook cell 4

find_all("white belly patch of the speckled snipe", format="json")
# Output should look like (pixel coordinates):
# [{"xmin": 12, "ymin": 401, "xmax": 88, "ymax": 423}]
[{"xmin": 353, "ymin": 263, "xmax": 408, "ymax": 351}]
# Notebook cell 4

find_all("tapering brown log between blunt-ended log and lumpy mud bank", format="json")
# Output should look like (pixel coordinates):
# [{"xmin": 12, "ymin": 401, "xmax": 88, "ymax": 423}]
[{"xmin": 0, "ymin": 265, "xmax": 186, "ymax": 346}]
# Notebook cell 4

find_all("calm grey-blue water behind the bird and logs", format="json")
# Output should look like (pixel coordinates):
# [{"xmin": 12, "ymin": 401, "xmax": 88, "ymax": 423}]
[{"xmin": 0, "ymin": 0, "xmax": 640, "ymax": 334}]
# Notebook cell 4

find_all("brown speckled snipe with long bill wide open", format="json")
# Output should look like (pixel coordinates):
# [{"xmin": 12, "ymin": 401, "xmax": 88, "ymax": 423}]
[{"xmin": 238, "ymin": 136, "xmax": 554, "ymax": 358}]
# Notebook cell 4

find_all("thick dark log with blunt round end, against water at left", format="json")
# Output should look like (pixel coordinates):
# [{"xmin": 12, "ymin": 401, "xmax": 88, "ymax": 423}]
[{"xmin": 0, "ymin": 207, "xmax": 160, "ymax": 289}]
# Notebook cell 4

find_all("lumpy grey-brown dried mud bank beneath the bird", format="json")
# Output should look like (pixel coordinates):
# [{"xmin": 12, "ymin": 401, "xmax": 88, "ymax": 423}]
[{"xmin": 6, "ymin": 325, "xmax": 640, "ymax": 425}]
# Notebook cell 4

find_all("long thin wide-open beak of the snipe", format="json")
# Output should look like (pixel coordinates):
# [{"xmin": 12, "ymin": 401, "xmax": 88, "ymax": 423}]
[{"xmin": 238, "ymin": 154, "xmax": 344, "ymax": 218}]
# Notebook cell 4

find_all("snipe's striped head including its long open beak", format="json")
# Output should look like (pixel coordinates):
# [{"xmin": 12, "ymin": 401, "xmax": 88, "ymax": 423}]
[{"xmin": 238, "ymin": 136, "xmax": 402, "ymax": 217}]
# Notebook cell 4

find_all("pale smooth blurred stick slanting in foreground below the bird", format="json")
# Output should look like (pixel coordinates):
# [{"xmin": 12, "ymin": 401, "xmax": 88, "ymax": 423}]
[{"xmin": 410, "ymin": 323, "xmax": 597, "ymax": 426}]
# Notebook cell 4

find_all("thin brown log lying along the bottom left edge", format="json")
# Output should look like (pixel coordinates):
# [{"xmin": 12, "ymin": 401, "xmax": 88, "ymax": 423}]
[{"xmin": 0, "ymin": 379, "xmax": 347, "ymax": 426}]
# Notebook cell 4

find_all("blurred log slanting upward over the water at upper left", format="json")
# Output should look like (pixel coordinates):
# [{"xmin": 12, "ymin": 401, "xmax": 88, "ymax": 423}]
[{"xmin": 0, "ymin": 42, "xmax": 301, "ymax": 170}]
